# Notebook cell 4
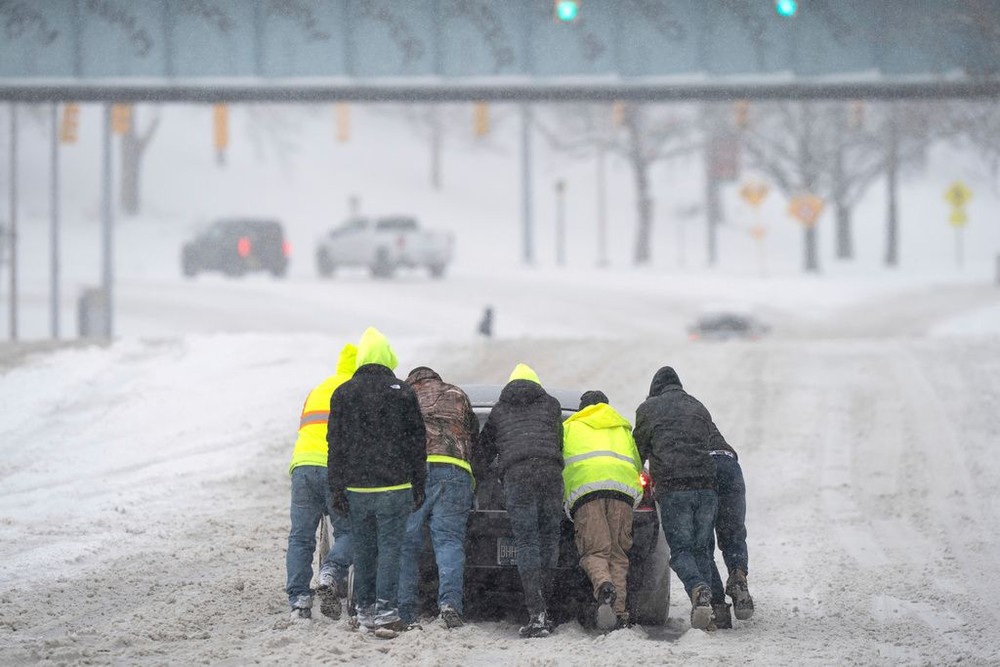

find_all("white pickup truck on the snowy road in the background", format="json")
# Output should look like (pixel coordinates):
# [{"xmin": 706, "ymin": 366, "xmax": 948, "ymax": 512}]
[{"xmin": 316, "ymin": 216, "xmax": 454, "ymax": 278}]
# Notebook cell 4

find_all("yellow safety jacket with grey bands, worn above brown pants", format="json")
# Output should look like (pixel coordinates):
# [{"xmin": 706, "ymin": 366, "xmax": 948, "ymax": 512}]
[{"xmin": 563, "ymin": 403, "xmax": 642, "ymax": 514}]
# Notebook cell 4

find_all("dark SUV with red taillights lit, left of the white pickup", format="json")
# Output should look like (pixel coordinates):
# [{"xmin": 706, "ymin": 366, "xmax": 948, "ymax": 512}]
[{"xmin": 181, "ymin": 218, "xmax": 291, "ymax": 278}]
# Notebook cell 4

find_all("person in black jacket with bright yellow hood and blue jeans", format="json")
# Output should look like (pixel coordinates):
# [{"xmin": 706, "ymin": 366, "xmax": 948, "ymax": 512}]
[{"xmin": 327, "ymin": 327, "xmax": 427, "ymax": 637}]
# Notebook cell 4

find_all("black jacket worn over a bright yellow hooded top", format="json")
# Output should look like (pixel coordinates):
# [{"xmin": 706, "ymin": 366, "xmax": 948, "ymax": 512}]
[{"xmin": 326, "ymin": 364, "xmax": 427, "ymax": 492}]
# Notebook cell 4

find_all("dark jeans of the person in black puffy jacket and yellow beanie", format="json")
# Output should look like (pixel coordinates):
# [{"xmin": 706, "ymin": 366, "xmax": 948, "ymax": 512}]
[{"xmin": 503, "ymin": 467, "xmax": 563, "ymax": 616}]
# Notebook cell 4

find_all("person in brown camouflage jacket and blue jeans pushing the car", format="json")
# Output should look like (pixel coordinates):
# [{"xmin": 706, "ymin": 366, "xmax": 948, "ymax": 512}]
[{"xmin": 399, "ymin": 366, "xmax": 479, "ymax": 628}]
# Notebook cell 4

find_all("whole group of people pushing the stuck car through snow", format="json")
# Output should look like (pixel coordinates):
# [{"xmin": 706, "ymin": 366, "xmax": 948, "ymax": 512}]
[{"xmin": 286, "ymin": 327, "xmax": 753, "ymax": 638}]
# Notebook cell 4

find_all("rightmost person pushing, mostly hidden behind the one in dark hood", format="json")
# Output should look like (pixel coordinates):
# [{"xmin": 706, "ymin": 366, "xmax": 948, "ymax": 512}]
[{"xmin": 709, "ymin": 424, "xmax": 753, "ymax": 629}]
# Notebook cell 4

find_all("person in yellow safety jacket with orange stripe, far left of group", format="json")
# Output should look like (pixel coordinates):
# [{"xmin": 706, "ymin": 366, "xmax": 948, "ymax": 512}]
[{"xmin": 285, "ymin": 343, "xmax": 357, "ymax": 619}]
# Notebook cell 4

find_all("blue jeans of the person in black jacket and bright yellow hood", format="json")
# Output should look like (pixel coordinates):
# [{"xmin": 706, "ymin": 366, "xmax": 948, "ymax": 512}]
[{"xmin": 347, "ymin": 488, "xmax": 413, "ymax": 623}]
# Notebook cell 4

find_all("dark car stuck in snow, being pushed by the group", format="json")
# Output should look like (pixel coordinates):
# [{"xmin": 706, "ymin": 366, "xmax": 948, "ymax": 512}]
[{"xmin": 402, "ymin": 385, "xmax": 670, "ymax": 625}]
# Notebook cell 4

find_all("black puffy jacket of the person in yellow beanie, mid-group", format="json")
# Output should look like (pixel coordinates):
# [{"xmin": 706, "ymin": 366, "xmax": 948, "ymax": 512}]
[{"xmin": 478, "ymin": 380, "xmax": 563, "ymax": 486}]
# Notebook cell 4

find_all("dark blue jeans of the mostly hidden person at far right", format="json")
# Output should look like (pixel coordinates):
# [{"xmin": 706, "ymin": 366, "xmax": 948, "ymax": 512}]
[{"xmin": 712, "ymin": 455, "xmax": 749, "ymax": 604}]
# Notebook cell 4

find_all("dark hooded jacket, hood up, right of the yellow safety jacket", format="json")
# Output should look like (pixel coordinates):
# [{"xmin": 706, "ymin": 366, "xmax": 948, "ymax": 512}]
[{"xmin": 633, "ymin": 366, "xmax": 718, "ymax": 496}]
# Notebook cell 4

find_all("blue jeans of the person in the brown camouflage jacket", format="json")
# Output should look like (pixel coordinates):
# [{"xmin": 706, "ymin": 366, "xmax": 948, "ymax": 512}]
[{"xmin": 399, "ymin": 463, "xmax": 472, "ymax": 623}]
